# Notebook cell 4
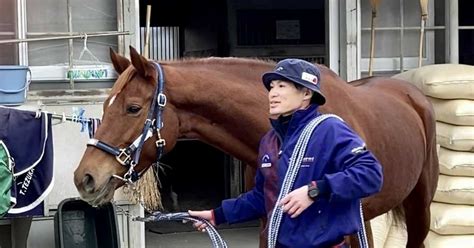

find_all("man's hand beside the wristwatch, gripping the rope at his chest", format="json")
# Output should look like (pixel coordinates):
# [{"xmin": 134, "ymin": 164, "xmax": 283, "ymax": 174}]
[{"xmin": 280, "ymin": 185, "xmax": 314, "ymax": 218}]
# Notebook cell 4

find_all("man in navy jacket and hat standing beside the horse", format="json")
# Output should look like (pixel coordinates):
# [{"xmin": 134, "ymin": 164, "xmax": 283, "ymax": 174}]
[{"xmin": 189, "ymin": 59, "xmax": 383, "ymax": 248}]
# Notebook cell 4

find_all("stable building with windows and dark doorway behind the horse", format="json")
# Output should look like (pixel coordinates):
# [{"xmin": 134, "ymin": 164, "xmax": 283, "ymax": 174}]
[{"xmin": 0, "ymin": 0, "xmax": 474, "ymax": 247}]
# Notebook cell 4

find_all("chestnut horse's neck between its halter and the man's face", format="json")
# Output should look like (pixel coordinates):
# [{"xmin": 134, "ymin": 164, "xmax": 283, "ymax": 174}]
[{"xmin": 167, "ymin": 60, "xmax": 269, "ymax": 164}]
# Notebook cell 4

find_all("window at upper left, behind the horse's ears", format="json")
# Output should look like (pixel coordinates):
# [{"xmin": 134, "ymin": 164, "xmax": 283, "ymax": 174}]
[{"xmin": 0, "ymin": 0, "xmax": 131, "ymax": 87}]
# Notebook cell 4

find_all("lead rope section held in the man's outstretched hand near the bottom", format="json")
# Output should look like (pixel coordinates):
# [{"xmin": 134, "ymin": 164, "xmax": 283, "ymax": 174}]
[{"xmin": 133, "ymin": 211, "xmax": 227, "ymax": 248}]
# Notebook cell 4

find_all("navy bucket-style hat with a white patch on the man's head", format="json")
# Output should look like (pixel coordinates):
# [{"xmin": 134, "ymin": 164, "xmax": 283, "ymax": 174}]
[{"xmin": 262, "ymin": 59, "xmax": 326, "ymax": 105}]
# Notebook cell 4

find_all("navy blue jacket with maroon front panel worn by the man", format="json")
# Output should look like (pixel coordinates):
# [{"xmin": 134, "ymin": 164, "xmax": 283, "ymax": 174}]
[{"xmin": 215, "ymin": 105, "xmax": 382, "ymax": 248}]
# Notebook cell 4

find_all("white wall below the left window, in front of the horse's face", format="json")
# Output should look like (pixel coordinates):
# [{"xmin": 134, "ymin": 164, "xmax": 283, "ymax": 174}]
[{"xmin": 4, "ymin": 93, "xmax": 145, "ymax": 248}]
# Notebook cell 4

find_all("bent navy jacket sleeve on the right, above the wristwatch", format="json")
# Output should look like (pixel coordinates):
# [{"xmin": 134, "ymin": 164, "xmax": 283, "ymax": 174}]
[{"xmin": 316, "ymin": 118, "xmax": 383, "ymax": 200}]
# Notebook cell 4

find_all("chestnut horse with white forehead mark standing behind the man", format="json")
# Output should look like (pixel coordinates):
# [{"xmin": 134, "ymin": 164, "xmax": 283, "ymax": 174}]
[{"xmin": 74, "ymin": 47, "xmax": 438, "ymax": 248}]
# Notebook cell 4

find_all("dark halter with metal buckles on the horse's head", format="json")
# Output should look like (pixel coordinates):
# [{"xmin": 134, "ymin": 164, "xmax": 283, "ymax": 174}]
[{"xmin": 87, "ymin": 62, "xmax": 166, "ymax": 183}]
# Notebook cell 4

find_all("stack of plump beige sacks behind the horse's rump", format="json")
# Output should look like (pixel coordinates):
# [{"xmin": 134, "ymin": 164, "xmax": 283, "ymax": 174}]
[{"xmin": 394, "ymin": 64, "xmax": 474, "ymax": 248}]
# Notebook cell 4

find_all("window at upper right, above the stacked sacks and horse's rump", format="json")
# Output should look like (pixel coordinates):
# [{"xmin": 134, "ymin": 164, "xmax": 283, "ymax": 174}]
[{"xmin": 361, "ymin": 0, "xmax": 438, "ymax": 72}]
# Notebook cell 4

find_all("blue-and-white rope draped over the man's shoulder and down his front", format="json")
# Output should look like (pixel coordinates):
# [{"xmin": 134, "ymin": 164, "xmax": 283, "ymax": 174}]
[{"xmin": 267, "ymin": 114, "xmax": 368, "ymax": 248}]
